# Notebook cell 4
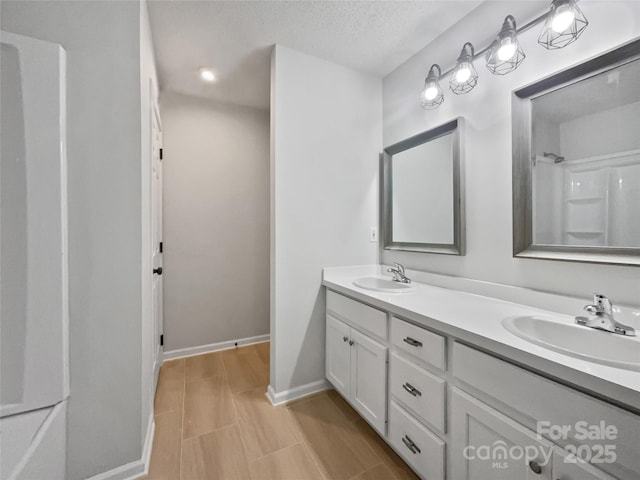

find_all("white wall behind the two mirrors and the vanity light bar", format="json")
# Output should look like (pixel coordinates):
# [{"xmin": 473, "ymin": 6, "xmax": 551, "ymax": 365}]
[{"xmin": 381, "ymin": 0, "xmax": 640, "ymax": 304}]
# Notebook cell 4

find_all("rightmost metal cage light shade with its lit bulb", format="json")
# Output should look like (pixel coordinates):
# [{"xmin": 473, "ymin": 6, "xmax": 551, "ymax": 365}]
[{"xmin": 538, "ymin": 0, "xmax": 589, "ymax": 50}]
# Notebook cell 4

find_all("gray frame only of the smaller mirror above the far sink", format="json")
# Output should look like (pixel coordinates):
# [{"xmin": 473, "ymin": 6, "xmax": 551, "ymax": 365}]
[{"xmin": 380, "ymin": 117, "xmax": 465, "ymax": 255}]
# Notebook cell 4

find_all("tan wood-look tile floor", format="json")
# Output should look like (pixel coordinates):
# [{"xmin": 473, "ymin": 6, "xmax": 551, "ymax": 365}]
[{"xmin": 146, "ymin": 343, "xmax": 417, "ymax": 480}]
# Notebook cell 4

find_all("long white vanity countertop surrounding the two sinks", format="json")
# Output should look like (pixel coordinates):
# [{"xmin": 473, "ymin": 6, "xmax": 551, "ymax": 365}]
[{"xmin": 322, "ymin": 265, "xmax": 640, "ymax": 410}]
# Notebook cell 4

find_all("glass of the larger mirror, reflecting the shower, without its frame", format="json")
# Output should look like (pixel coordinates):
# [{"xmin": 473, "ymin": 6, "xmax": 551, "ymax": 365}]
[{"xmin": 531, "ymin": 60, "xmax": 640, "ymax": 248}]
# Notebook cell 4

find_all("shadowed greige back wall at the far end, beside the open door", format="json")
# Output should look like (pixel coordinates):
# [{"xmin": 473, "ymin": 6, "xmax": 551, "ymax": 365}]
[{"xmin": 160, "ymin": 92, "xmax": 269, "ymax": 352}]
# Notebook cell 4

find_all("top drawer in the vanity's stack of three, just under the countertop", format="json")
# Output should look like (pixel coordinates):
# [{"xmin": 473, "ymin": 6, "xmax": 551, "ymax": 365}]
[{"xmin": 391, "ymin": 317, "xmax": 446, "ymax": 370}]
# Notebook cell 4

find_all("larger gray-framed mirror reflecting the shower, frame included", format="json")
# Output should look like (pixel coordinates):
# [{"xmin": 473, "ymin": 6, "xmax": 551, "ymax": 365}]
[{"xmin": 512, "ymin": 40, "xmax": 640, "ymax": 265}]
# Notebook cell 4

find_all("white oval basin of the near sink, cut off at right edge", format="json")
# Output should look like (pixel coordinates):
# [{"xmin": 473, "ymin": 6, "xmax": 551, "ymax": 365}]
[{"xmin": 502, "ymin": 316, "xmax": 640, "ymax": 371}]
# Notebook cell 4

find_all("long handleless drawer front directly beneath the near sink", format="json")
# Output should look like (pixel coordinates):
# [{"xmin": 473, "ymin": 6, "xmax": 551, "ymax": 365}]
[{"xmin": 453, "ymin": 342, "xmax": 640, "ymax": 480}]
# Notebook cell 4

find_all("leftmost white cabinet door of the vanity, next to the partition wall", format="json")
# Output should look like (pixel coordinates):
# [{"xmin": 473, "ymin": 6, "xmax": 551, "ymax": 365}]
[{"xmin": 325, "ymin": 315, "xmax": 351, "ymax": 398}]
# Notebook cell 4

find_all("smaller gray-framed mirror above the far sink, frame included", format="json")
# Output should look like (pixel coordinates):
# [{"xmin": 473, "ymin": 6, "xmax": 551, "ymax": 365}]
[{"xmin": 381, "ymin": 118, "xmax": 464, "ymax": 255}]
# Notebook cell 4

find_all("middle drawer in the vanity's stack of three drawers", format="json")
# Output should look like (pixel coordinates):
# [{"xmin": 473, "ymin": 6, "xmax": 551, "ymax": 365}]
[{"xmin": 389, "ymin": 353, "xmax": 447, "ymax": 433}]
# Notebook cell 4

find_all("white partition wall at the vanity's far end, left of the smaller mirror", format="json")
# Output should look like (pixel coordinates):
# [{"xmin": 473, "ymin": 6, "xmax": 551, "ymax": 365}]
[{"xmin": 270, "ymin": 45, "xmax": 382, "ymax": 395}]
